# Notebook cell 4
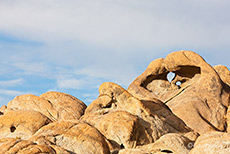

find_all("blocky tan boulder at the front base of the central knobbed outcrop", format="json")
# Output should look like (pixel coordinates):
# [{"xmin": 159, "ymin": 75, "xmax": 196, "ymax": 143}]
[{"xmin": 82, "ymin": 110, "xmax": 152, "ymax": 150}]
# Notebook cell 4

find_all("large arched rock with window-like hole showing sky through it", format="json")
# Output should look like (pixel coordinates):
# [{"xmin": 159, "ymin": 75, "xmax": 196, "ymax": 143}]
[{"xmin": 128, "ymin": 51, "xmax": 229, "ymax": 133}]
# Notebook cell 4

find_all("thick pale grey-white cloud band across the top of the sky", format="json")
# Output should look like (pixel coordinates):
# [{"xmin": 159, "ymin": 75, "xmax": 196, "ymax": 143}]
[{"xmin": 0, "ymin": 0, "xmax": 230, "ymax": 49}]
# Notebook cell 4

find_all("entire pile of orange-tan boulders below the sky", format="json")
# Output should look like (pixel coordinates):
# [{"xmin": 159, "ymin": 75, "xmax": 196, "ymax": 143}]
[{"xmin": 0, "ymin": 51, "xmax": 230, "ymax": 154}]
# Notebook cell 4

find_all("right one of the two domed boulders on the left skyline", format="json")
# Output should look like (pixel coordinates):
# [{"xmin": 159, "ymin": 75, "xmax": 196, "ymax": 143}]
[{"xmin": 40, "ymin": 92, "xmax": 87, "ymax": 121}]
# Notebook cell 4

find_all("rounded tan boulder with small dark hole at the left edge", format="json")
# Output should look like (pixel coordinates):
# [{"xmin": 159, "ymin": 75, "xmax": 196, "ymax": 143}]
[{"xmin": 0, "ymin": 110, "xmax": 50, "ymax": 139}]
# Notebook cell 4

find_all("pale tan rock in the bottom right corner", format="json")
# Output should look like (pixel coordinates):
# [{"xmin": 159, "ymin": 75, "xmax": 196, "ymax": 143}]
[{"xmin": 190, "ymin": 131, "xmax": 230, "ymax": 154}]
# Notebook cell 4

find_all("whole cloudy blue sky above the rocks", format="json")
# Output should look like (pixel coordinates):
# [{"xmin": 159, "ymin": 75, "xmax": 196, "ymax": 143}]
[{"xmin": 0, "ymin": 0, "xmax": 230, "ymax": 106}]
